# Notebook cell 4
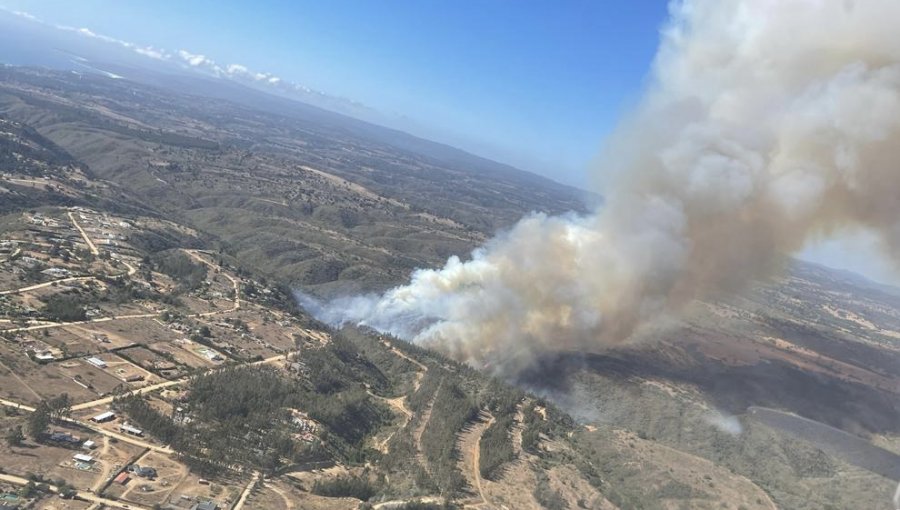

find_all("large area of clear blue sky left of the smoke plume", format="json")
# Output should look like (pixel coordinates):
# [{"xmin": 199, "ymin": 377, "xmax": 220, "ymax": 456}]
[{"xmin": 0, "ymin": 0, "xmax": 667, "ymax": 186}]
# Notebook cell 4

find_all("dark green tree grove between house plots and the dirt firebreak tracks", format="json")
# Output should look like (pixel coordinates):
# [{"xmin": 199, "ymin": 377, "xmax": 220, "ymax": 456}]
[{"xmin": 116, "ymin": 349, "xmax": 389, "ymax": 472}]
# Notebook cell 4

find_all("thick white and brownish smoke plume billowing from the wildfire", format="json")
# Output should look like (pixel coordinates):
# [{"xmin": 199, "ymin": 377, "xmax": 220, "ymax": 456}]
[{"xmin": 306, "ymin": 0, "xmax": 900, "ymax": 368}]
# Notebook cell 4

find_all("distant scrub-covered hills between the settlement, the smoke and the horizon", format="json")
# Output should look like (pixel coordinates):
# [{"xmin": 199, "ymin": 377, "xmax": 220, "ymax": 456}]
[{"xmin": 0, "ymin": 67, "xmax": 583, "ymax": 292}]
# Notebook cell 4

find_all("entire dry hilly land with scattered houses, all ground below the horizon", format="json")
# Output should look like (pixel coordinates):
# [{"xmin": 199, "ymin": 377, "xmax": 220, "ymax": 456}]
[{"xmin": 0, "ymin": 67, "xmax": 900, "ymax": 510}]
